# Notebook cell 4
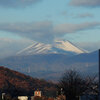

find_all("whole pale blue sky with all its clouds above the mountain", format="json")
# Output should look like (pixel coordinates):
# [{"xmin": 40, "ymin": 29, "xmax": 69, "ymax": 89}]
[{"xmin": 0, "ymin": 0, "xmax": 100, "ymax": 57}]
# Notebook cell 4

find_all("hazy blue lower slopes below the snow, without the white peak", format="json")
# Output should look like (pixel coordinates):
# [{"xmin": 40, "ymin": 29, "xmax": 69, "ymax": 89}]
[{"xmin": 0, "ymin": 51, "xmax": 98, "ymax": 81}]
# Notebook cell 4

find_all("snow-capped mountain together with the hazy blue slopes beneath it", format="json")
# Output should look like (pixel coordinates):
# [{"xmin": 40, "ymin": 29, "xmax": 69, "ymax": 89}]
[{"xmin": 0, "ymin": 41, "xmax": 98, "ymax": 81}]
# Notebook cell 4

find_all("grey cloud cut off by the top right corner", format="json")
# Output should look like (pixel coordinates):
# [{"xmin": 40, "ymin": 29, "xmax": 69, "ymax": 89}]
[{"xmin": 70, "ymin": 0, "xmax": 100, "ymax": 7}]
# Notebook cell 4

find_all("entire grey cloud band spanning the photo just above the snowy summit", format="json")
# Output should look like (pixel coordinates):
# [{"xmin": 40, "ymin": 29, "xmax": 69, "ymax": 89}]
[{"xmin": 0, "ymin": 22, "xmax": 100, "ymax": 42}]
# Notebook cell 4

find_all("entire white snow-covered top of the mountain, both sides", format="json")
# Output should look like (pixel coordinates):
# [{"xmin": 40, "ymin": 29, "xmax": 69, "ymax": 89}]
[{"xmin": 17, "ymin": 41, "xmax": 86, "ymax": 55}]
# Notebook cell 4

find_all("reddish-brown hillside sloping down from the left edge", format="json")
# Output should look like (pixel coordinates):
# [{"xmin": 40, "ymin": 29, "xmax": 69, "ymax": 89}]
[{"xmin": 0, "ymin": 66, "xmax": 56, "ymax": 96}]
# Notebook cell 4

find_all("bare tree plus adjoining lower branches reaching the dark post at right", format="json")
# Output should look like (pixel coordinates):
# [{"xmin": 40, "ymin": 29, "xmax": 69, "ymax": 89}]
[{"xmin": 57, "ymin": 70, "xmax": 98, "ymax": 100}]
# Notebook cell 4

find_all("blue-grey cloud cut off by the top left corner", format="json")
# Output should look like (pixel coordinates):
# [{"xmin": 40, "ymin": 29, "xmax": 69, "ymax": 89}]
[{"xmin": 0, "ymin": 0, "xmax": 42, "ymax": 8}]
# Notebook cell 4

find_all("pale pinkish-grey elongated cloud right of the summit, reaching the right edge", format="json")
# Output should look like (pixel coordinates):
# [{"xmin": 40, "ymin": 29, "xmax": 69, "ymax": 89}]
[{"xmin": 54, "ymin": 22, "xmax": 100, "ymax": 34}]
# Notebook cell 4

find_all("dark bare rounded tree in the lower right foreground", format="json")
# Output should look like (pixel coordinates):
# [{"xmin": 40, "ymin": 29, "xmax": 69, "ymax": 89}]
[{"xmin": 58, "ymin": 70, "xmax": 95, "ymax": 100}]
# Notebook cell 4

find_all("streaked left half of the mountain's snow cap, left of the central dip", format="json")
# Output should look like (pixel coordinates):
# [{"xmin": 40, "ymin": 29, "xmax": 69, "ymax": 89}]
[{"xmin": 17, "ymin": 42, "xmax": 56, "ymax": 55}]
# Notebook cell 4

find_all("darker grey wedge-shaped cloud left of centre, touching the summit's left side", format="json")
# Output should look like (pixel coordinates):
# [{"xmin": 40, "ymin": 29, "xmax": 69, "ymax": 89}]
[{"xmin": 0, "ymin": 22, "xmax": 54, "ymax": 42}]
